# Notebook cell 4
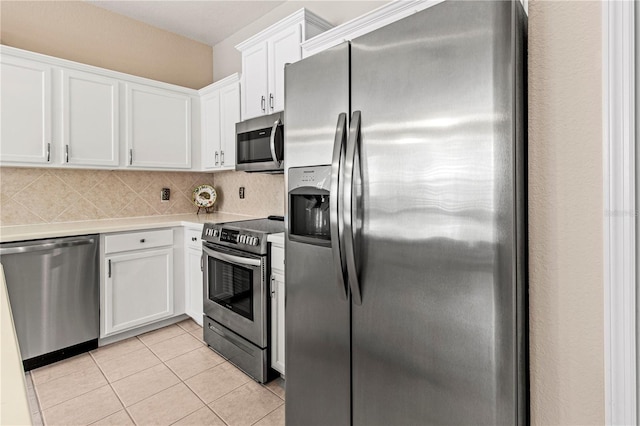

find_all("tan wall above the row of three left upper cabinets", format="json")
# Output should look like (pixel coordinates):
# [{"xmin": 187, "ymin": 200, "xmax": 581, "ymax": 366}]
[{"xmin": 0, "ymin": 0, "xmax": 213, "ymax": 89}]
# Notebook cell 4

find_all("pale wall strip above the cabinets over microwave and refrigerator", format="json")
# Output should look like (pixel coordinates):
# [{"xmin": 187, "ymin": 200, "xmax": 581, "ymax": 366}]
[{"xmin": 213, "ymin": 0, "xmax": 388, "ymax": 81}]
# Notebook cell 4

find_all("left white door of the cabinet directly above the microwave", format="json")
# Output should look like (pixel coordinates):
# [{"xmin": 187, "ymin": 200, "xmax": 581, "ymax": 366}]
[{"xmin": 242, "ymin": 43, "xmax": 269, "ymax": 120}]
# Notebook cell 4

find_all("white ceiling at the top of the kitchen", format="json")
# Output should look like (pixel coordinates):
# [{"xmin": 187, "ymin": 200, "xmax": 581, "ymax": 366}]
[{"xmin": 86, "ymin": 0, "xmax": 284, "ymax": 46}]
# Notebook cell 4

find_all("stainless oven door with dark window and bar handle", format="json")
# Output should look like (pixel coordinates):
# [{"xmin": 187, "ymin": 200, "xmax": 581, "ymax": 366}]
[{"xmin": 202, "ymin": 243, "xmax": 267, "ymax": 348}]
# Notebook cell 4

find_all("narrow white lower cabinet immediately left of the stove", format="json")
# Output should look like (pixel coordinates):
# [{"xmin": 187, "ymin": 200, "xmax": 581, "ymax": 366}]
[{"xmin": 184, "ymin": 226, "xmax": 203, "ymax": 325}]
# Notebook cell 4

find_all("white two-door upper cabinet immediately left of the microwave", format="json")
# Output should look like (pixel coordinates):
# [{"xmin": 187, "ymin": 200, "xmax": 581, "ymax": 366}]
[{"xmin": 200, "ymin": 74, "xmax": 240, "ymax": 171}]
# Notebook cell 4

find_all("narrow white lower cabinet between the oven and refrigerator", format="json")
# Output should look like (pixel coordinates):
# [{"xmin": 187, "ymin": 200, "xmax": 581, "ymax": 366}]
[{"xmin": 268, "ymin": 235, "xmax": 285, "ymax": 375}]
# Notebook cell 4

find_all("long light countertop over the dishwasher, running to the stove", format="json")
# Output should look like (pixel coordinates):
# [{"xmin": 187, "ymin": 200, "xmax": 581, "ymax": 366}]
[{"xmin": 0, "ymin": 213, "xmax": 255, "ymax": 242}]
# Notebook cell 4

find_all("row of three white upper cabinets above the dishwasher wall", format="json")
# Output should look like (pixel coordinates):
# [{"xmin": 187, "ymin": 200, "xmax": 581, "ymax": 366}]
[{"xmin": 0, "ymin": 46, "xmax": 198, "ymax": 170}]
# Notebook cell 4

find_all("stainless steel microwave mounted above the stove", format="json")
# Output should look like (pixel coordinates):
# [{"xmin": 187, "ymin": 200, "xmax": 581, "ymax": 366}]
[{"xmin": 236, "ymin": 112, "xmax": 284, "ymax": 173}]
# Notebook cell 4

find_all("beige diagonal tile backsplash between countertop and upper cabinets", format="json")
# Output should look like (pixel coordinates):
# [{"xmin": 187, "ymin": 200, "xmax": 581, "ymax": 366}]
[{"xmin": 0, "ymin": 167, "xmax": 284, "ymax": 226}]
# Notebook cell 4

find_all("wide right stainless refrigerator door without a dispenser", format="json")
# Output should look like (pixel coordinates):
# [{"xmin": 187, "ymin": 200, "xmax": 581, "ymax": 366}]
[{"xmin": 350, "ymin": 1, "xmax": 524, "ymax": 425}]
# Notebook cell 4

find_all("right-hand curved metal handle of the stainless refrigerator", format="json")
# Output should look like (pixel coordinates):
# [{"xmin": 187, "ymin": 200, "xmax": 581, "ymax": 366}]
[{"xmin": 344, "ymin": 111, "xmax": 362, "ymax": 305}]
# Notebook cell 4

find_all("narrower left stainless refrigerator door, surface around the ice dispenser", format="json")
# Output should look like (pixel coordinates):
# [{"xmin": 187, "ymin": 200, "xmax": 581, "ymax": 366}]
[{"xmin": 284, "ymin": 44, "xmax": 351, "ymax": 426}]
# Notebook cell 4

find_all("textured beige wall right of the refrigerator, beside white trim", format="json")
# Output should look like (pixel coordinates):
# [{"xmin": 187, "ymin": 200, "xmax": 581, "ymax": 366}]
[{"xmin": 529, "ymin": 0, "xmax": 604, "ymax": 425}]
